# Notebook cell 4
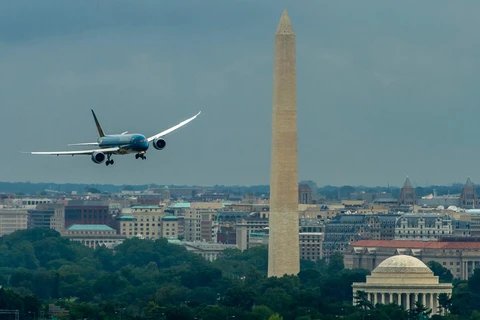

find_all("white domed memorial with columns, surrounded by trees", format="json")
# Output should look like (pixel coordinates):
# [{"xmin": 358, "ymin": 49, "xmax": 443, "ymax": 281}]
[{"xmin": 352, "ymin": 255, "xmax": 452, "ymax": 315}]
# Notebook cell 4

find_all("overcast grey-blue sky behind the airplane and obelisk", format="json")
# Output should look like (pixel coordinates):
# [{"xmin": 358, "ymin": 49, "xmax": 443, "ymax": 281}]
[{"xmin": 0, "ymin": 0, "xmax": 480, "ymax": 186}]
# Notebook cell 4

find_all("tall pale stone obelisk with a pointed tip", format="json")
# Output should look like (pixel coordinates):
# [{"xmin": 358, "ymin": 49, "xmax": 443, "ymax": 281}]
[{"xmin": 268, "ymin": 10, "xmax": 300, "ymax": 277}]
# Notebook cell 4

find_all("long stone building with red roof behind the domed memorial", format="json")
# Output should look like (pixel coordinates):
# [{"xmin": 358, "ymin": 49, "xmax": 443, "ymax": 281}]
[{"xmin": 344, "ymin": 238, "xmax": 480, "ymax": 280}]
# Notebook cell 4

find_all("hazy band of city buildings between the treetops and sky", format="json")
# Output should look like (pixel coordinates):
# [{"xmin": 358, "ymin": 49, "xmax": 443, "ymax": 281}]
[{"xmin": 0, "ymin": 177, "xmax": 480, "ymax": 319}]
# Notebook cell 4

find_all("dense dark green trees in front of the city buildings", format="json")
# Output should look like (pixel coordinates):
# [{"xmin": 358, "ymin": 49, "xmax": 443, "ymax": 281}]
[{"xmin": 0, "ymin": 229, "xmax": 480, "ymax": 320}]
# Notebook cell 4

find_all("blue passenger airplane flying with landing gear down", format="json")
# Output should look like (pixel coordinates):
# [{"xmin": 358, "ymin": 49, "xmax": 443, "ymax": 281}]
[{"xmin": 27, "ymin": 110, "xmax": 201, "ymax": 166}]
